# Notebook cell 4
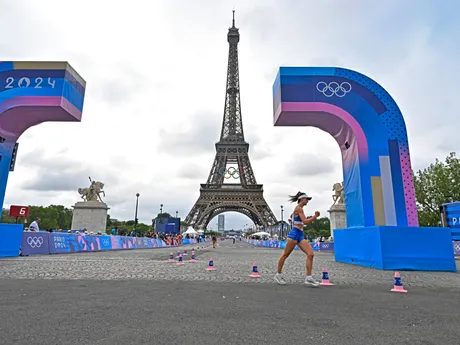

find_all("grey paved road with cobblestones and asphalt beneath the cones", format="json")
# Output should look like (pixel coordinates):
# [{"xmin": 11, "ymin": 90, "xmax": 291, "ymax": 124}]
[{"xmin": 0, "ymin": 241, "xmax": 460, "ymax": 345}]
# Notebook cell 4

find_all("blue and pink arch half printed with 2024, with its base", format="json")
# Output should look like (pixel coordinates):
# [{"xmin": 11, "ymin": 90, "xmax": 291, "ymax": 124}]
[{"xmin": 0, "ymin": 62, "xmax": 86, "ymax": 256}]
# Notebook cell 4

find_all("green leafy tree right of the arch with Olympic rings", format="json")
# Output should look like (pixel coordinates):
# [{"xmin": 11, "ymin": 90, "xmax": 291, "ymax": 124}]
[{"xmin": 414, "ymin": 152, "xmax": 460, "ymax": 226}]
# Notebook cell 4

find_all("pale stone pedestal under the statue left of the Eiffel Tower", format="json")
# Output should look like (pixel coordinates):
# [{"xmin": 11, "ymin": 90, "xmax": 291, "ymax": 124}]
[{"xmin": 72, "ymin": 201, "xmax": 109, "ymax": 234}]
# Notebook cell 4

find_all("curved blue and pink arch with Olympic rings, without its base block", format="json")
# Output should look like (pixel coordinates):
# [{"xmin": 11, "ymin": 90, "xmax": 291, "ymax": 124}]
[{"xmin": 273, "ymin": 67, "xmax": 418, "ymax": 227}]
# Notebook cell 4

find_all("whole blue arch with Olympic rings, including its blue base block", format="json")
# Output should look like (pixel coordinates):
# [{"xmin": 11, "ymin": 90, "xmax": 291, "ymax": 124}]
[{"xmin": 273, "ymin": 67, "xmax": 456, "ymax": 271}]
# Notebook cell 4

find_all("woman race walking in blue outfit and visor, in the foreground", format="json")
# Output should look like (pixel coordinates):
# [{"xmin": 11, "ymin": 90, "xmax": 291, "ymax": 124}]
[{"xmin": 275, "ymin": 192, "xmax": 319, "ymax": 286}]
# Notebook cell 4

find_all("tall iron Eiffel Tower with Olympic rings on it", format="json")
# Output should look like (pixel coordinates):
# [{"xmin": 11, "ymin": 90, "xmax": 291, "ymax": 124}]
[{"xmin": 185, "ymin": 11, "xmax": 277, "ymax": 229}]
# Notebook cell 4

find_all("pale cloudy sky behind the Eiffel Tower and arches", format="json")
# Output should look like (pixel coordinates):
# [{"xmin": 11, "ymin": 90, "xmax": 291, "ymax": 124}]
[{"xmin": 0, "ymin": 0, "xmax": 460, "ymax": 228}]
